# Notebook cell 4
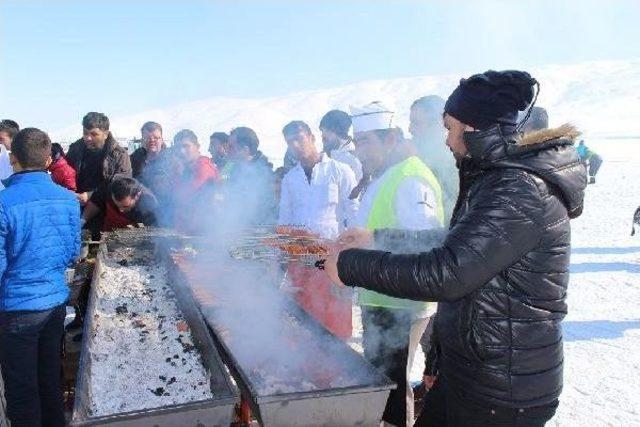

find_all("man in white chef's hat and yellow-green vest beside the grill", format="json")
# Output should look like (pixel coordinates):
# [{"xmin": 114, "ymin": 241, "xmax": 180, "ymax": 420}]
[{"xmin": 332, "ymin": 102, "xmax": 444, "ymax": 427}]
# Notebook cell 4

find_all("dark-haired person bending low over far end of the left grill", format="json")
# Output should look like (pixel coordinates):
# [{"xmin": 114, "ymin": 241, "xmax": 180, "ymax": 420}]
[{"xmin": 82, "ymin": 176, "xmax": 158, "ymax": 231}]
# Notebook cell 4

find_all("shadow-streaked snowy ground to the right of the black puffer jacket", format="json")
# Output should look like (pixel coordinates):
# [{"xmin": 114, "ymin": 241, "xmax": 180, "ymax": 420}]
[{"xmin": 549, "ymin": 139, "xmax": 640, "ymax": 426}]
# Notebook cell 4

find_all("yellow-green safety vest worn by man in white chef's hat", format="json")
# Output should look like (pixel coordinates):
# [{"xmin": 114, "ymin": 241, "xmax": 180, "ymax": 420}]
[{"xmin": 358, "ymin": 156, "xmax": 444, "ymax": 311}]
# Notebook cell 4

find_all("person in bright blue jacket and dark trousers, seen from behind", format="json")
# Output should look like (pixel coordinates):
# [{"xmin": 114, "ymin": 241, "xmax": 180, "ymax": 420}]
[{"xmin": 0, "ymin": 128, "xmax": 80, "ymax": 427}]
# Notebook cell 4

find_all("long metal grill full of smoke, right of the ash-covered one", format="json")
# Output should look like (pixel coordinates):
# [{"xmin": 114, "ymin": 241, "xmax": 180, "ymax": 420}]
[{"xmin": 167, "ymin": 234, "xmax": 394, "ymax": 427}]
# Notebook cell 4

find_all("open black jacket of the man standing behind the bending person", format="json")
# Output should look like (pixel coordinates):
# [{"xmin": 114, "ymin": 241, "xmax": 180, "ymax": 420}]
[{"xmin": 67, "ymin": 133, "xmax": 131, "ymax": 201}]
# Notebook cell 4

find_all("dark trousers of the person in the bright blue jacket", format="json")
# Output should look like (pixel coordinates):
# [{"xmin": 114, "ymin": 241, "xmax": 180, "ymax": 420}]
[{"xmin": 0, "ymin": 305, "xmax": 65, "ymax": 427}]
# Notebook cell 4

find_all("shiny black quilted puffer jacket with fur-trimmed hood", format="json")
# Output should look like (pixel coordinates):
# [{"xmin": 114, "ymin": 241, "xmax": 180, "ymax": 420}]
[{"xmin": 338, "ymin": 126, "xmax": 587, "ymax": 407}]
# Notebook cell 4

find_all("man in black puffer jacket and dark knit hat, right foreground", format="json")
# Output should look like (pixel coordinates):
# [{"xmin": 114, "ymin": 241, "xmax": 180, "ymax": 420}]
[{"xmin": 325, "ymin": 71, "xmax": 587, "ymax": 427}]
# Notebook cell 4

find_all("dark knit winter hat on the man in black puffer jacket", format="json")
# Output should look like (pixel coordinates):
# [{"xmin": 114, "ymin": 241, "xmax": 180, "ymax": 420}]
[{"xmin": 444, "ymin": 70, "xmax": 537, "ymax": 130}]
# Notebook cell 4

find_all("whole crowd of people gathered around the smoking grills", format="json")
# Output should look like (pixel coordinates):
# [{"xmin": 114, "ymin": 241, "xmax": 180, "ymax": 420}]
[{"xmin": 0, "ymin": 67, "xmax": 599, "ymax": 426}]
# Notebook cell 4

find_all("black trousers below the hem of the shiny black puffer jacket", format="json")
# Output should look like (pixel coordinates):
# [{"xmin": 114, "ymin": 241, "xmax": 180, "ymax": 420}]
[{"xmin": 415, "ymin": 375, "xmax": 558, "ymax": 427}]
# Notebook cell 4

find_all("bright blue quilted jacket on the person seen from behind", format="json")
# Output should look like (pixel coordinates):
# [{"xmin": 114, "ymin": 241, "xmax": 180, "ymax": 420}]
[{"xmin": 0, "ymin": 171, "xmax": 80, "ymax": 311}]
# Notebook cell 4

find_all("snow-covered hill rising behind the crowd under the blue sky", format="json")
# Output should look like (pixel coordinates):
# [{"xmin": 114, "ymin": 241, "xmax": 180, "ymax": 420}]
[{"xmin": 50, "ymin": 60, "xmax": 640, "ymax": 163}]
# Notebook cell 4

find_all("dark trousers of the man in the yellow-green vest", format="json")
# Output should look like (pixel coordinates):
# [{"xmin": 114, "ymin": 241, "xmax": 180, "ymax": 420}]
[{"xmin": 362, "ymin": 307, "xmax": 412, "ymax": 426}]
